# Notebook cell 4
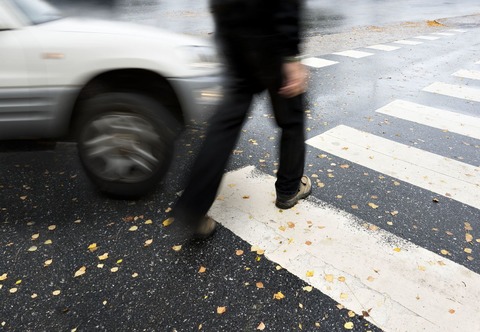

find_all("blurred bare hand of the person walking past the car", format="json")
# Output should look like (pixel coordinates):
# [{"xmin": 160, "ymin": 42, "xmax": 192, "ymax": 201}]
[{"xmin": 278, "ymin": 61, "xmax": 308, "ymax": 98}]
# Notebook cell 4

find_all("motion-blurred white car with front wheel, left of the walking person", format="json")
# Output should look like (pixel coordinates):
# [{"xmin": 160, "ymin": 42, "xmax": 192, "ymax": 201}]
[{"xmin": 0, "ymin": 0, "xmax": 221, "ymax": 197}]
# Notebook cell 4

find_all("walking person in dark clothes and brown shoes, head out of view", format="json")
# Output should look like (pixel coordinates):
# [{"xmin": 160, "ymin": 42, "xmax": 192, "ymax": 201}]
[{"xmin": 173, "ymin": 0, "xmax": 311, "ymax": 238}]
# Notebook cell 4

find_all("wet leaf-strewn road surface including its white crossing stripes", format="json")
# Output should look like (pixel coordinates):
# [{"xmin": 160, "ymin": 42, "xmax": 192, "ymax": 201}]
[{"xmin": 0, "ymin": 2, "xmax": 480, "ymax": 331}]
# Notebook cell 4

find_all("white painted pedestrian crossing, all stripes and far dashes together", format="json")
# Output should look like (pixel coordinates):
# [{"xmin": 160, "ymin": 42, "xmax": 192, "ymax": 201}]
[{"xmin": 214, "ymin": 33, "xmax": 480, "ymax": 331}]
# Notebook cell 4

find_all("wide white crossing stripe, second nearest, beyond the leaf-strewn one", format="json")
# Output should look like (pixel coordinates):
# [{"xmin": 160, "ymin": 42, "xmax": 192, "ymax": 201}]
[{"xmin": 307, "ymin": 125, "xmax": 480, "ymax": 209}]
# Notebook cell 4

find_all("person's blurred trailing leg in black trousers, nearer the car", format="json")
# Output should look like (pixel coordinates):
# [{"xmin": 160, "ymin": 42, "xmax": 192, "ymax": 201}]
[{"xmin": 174, "ymin": 88, "xmax": 253, "ymax": 231}]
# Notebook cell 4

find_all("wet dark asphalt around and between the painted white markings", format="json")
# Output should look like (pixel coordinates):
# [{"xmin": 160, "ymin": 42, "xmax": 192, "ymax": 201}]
[{"xmin": 0, "ymin": 1, "xmax": 480, "ymax": 331}]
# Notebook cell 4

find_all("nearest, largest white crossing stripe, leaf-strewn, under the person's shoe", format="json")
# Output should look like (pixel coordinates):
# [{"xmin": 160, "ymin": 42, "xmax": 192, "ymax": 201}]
[{"xmin": 209, "ymin": 166, "xmax": 480, "ymax": 332}]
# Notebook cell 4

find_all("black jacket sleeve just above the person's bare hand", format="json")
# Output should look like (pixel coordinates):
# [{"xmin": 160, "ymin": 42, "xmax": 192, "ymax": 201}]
[{"xmin": 272, "ymin": 0, "xmax": 303, "ymax": 57}]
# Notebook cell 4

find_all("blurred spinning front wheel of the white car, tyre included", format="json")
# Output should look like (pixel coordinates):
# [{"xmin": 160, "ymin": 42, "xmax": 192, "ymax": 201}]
[{"xmin": 77, "ymin": 93, "xmax": 178, "ymax": 198}]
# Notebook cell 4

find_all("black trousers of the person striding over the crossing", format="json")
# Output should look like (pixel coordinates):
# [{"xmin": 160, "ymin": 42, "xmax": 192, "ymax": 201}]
[{"xmin": 174, "ymin": 36, "xmax": 305, "ymax": 227}]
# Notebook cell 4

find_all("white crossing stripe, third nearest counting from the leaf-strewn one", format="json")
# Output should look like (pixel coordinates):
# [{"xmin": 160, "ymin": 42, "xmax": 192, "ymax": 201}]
[{"xmin": 376, "ymin": 100, "xmax": 480, "ymax": 140}]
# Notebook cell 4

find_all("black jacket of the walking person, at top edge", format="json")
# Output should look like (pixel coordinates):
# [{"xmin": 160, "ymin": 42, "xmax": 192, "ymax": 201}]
[{"xmin": 210, "ymin": 0, "xmax": 302, "ymax": 57}]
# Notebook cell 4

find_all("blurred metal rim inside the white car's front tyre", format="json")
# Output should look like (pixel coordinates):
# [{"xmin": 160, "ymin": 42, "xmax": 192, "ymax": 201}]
[{"xmin": 81, "ymin": 114, "xmax": 166, "ymax": 183}]
